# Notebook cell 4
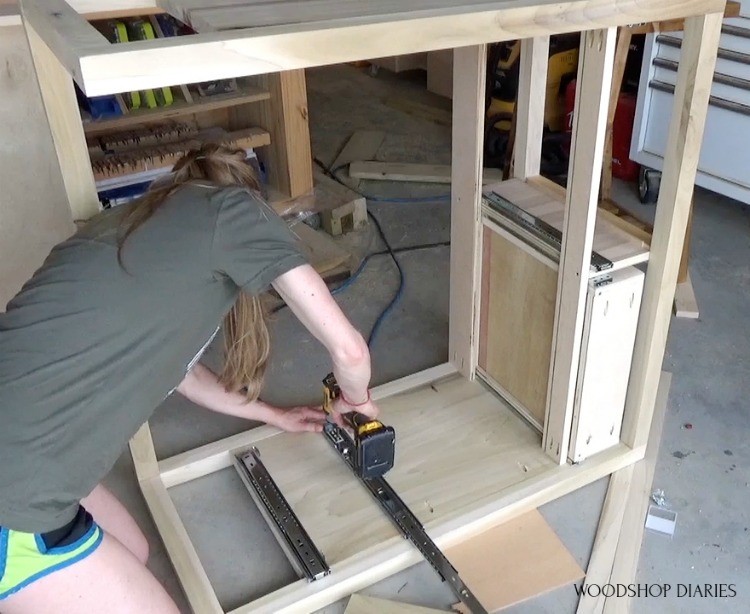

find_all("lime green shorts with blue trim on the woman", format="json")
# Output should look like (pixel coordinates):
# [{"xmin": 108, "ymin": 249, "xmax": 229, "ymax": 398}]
[{"xmin": 0, "ymin": 507, "xmax": 104, "ymax": 601}]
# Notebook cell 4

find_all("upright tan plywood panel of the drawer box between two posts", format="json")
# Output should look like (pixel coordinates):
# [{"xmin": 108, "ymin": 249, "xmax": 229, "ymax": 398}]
[{"xmin": 479, "ymin": 228, "xmax": 557, "ymax": 425}]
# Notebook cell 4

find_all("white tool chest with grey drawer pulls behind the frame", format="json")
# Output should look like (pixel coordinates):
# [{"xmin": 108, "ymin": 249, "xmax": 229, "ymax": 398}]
[{"xmin": 630, "ymin": 0, "xmax": 750, "ymax": 203}]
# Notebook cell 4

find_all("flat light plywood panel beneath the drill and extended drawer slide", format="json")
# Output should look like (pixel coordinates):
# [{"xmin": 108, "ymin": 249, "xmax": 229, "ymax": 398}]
[{"xmin": 257, "ymin": 376, "xmax": 553, "ymax": 566}]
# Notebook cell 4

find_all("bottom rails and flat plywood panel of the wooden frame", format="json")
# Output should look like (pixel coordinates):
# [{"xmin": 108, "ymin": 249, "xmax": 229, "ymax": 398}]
[{"xmin": 137, "ymin": 364, "xmax": 643, "ymax": 614}]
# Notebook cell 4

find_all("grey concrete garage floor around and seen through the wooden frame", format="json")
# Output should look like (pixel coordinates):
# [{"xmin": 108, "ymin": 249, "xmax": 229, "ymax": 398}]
[{"xmin": 101, "ymin": 67, "xmax": 750, "ymax": 614}]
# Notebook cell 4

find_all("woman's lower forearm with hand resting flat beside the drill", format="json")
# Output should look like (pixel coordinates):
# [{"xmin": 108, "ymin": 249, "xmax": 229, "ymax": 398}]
[{"xmin": 177, "ymin": 363, "xmax": 325, "ymax": 432}]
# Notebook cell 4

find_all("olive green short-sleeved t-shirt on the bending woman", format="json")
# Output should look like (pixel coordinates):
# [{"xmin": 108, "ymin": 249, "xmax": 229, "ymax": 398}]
[{"xmin": 0, "ymin": 185, "xmax": 305, "ymax": 532}]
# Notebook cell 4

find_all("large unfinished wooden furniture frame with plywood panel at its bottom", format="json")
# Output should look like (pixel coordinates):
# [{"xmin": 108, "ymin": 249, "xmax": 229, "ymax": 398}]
[{"xmin": 14, "ymin": 0, "xmax": 725, "ymax": 614}]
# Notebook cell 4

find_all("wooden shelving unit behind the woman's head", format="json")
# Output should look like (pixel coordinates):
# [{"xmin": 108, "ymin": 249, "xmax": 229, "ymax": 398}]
[{"xmin": 49, "ymin": 7, "xmax": 313, "ymax": 212}]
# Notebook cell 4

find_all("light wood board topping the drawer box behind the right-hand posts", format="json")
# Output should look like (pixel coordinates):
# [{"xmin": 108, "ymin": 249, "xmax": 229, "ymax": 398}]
[{"xmin": 486, "ymin": 179, "xmax": 649, "ymax": 270}]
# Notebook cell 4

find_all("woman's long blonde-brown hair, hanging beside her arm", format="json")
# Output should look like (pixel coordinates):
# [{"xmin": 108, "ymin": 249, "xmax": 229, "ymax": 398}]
[{"xmin": 117, "ymin": 143, "xmax": 270, "ymax": 402}]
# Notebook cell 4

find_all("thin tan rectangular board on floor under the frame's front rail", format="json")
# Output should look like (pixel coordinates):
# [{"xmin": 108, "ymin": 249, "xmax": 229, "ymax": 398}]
[{"xmin": 445, "ymin": 510, "xmax": 584, "ymax": 613}]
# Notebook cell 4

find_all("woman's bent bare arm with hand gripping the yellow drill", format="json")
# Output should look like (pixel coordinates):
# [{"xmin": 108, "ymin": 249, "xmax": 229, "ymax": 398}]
[{"xmin": 273, "ymin": 264, "xmax": 378, "ymax": 418}]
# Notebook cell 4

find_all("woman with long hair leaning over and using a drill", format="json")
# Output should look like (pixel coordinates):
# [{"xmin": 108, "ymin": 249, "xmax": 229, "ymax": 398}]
[{"xmin": 0, "ymin": 145, "xmax": 378, "ymax": 614}]
